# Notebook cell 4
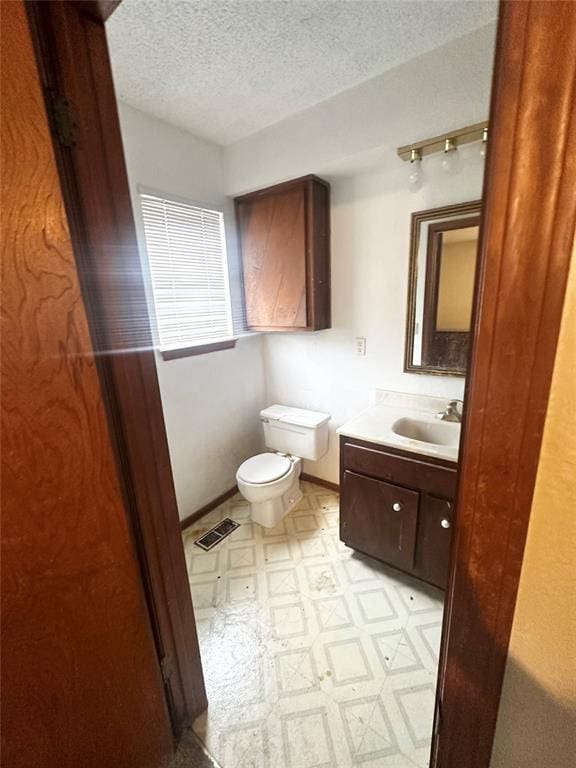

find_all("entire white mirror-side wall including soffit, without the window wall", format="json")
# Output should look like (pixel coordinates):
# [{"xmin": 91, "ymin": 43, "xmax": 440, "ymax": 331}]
[{"xmin": 225, "ymin": 27, "xmax": 494, "ymax": 482}]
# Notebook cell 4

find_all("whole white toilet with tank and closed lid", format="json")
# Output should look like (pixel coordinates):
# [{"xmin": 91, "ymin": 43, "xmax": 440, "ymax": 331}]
[{"xmin": 236, "ymin": 405, "xmax": 330, "ymax": 528}]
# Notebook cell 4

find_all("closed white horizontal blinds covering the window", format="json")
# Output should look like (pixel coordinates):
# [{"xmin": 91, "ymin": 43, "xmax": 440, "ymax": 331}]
[{"xmin": 140, "ymin": 193, "xmax": 232, "ymax": 349}]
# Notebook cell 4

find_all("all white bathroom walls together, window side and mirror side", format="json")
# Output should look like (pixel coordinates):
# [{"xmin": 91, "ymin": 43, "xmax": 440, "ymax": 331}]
[{"xmin": 113, "ymin": 25, "xmax": 494, "ymax": 498}]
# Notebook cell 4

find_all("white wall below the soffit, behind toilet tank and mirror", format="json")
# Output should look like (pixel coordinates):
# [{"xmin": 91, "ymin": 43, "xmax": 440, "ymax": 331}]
[{"xmin": 258, "ymin": 152, "xmax": 482, "ymax": 482}]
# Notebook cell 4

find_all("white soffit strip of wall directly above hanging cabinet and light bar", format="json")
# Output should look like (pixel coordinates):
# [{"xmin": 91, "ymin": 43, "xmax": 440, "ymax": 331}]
[{"xmin": 225, "ymin": 24, "xmax": 495, "ymax": 194}]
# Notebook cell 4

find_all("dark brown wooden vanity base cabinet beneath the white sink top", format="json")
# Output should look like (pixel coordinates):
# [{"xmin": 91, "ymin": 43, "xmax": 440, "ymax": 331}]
[{"xmin": 340, "ymin": 436, "xmax": 457, "ymax": 589}]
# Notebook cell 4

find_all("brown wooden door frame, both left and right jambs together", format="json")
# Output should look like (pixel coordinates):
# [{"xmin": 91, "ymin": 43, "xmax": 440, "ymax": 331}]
[{"xmin": 27, "ymin": 0, "xmax": 576, "ymax": 768}]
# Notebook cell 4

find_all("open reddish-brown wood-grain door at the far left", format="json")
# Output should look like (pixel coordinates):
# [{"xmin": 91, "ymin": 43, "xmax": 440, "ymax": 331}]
[{"xmin": 1, "ymin": 2, "xmax": 171, "ymax": 768}]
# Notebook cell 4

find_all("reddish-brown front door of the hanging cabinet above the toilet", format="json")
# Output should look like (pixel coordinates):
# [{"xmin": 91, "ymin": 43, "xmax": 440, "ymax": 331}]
[{"xmin": 236, "ymin": 184, "xmax": 307, "ymax": 330}]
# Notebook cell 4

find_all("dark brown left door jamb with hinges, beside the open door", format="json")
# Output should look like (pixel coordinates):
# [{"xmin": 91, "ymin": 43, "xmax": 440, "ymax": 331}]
[{"xmin": 26, "ymin": 2, "xmax": 207, "ymax": 735}]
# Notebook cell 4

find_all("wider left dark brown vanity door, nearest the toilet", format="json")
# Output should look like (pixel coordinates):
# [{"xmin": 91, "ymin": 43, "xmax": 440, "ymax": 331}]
[{"xmin": 340, "ymin": 470, "xmax": 420, "ymax": 571}]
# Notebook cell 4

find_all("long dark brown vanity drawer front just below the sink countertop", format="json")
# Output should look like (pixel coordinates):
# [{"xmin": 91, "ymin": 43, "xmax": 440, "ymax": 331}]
[{"xmin": 340, "ymin": 438, "xmax": 457, "ymax": 498}]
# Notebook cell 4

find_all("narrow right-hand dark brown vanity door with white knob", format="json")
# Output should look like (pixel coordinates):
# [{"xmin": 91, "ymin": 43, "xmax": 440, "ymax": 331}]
[{"xmin": 415, "ymin": 495, "xmax": 454, "ymax": 589}]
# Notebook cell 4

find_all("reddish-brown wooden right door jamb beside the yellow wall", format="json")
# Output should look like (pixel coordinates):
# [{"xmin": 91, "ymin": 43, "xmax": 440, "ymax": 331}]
[{"xmin": 432, "ymin": 0, "xmax": 576, "ymax": 768}]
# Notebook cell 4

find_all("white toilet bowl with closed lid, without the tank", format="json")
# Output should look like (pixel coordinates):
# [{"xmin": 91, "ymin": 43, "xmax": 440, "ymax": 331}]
[{"xmin": 236, "ymin": 453, "xmax": 302, "ymax": 528}]
